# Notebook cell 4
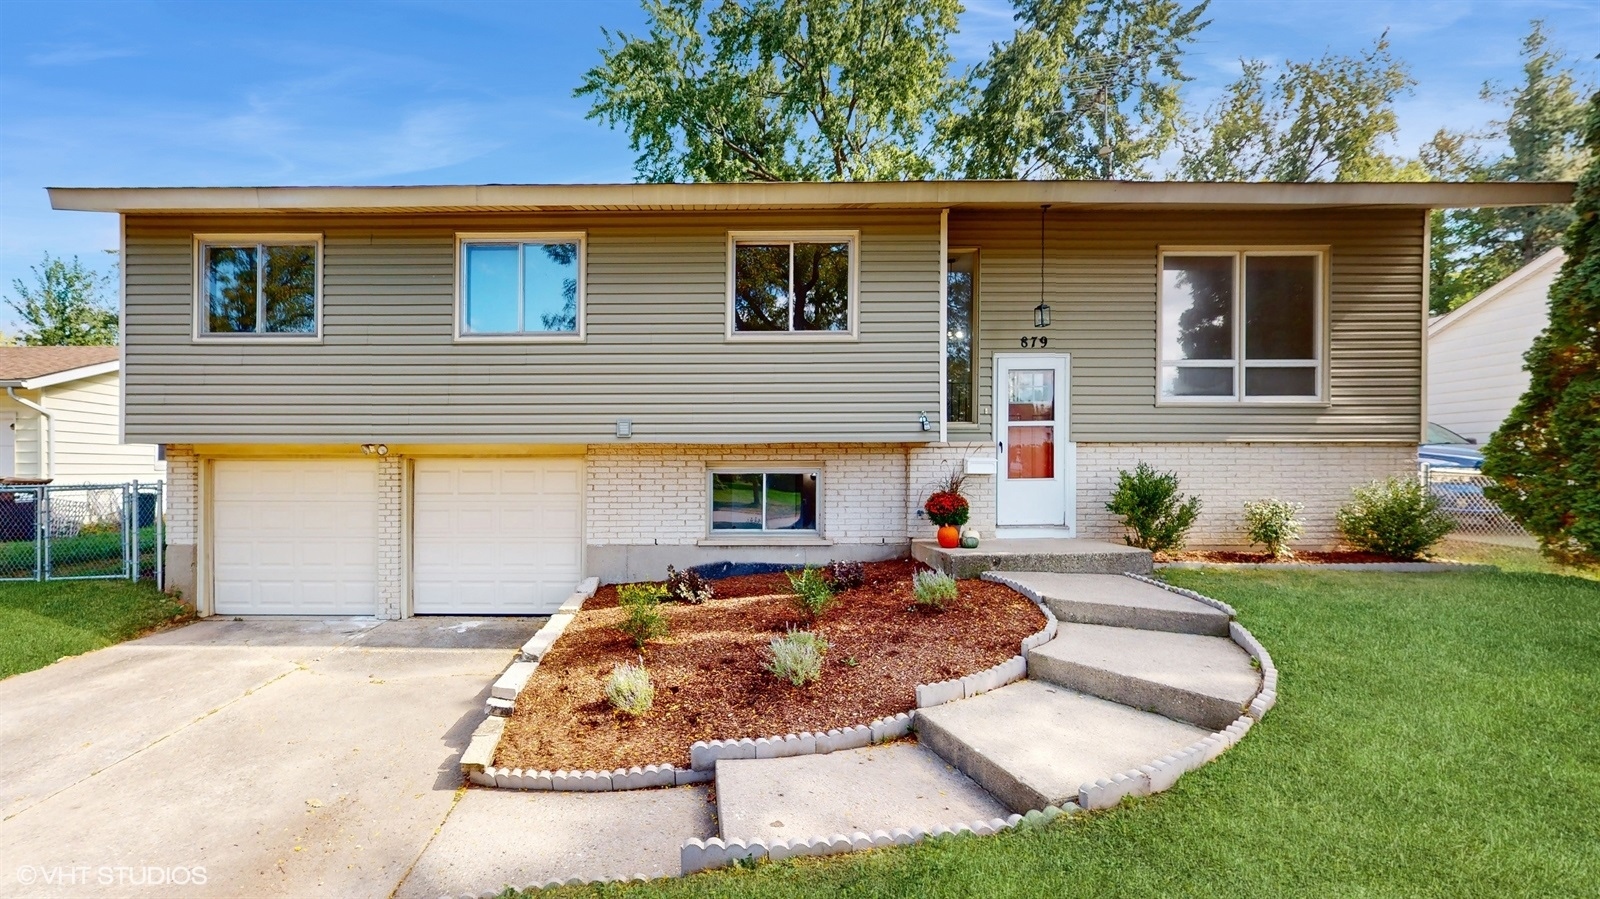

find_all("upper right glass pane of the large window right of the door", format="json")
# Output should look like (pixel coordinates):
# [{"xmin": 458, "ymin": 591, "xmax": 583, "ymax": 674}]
[{"xmin": 1245, "ymin": 256, "xmax": 1317, "ymax": 358}]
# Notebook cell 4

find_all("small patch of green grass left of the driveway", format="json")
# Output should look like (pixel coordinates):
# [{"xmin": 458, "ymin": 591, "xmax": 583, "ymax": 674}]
[{"xmin": 0, "ymin": 581, "xmax": 186, "ymax": 678}]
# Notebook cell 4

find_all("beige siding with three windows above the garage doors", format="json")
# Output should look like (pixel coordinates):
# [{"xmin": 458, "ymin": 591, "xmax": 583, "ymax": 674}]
[{"xmin": 123, "ymin": 210, "xmax": 939, "ymax": 443}]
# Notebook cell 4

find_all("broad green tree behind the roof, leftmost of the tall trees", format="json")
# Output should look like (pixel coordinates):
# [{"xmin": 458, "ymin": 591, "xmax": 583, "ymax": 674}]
[{"xmin": 576, "ymin": 0, "xmax": 960, "ymax": 181}]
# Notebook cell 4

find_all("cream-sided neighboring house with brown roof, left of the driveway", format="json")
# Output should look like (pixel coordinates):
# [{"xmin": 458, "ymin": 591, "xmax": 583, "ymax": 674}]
[{"xmin": 0, "ymin": 347, "xmax": 166, "ymax": 485}]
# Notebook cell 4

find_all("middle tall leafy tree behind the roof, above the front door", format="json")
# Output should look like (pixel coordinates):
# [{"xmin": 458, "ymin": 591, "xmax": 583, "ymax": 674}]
[{"xmin": 941, "ymin": 0, "xmax": 1210, "ymax": 179}]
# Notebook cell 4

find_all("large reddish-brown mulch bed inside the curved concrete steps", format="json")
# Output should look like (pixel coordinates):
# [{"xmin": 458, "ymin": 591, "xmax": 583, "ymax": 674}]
[{"xmin": 494, "ymin": 560, "xmax": 1045, "ymax": 771}]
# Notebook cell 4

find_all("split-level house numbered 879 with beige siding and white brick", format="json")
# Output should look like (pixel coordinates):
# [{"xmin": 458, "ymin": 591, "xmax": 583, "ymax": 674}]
[{"xmin": 51, "ymin": 182, "xmax": 1571, "ymax": 617}]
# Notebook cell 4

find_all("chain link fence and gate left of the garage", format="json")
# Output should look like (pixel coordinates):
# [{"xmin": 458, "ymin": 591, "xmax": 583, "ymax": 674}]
[{"xmin": 0, "ymin": 481, "xmax": 165, "ymax": 585}]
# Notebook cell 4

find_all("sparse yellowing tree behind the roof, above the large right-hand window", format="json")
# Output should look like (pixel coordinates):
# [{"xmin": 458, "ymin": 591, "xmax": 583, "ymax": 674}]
[{"xmin": 1176, "ymin": 35, "xmax": 1414, "ymax": 181}]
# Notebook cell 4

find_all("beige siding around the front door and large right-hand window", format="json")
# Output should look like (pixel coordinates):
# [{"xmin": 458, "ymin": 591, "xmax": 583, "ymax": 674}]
[{"xmin": 950, "ymin": 208, "xmax": 1426, "ymax": 443}]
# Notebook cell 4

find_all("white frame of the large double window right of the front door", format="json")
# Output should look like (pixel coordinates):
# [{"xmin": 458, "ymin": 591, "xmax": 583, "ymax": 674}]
[{"xmin": 1155, "ymin": 245, "xmax": 1330, "ymax": 406}]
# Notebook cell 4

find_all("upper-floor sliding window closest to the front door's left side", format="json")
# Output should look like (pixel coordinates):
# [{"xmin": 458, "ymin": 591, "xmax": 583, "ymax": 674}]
[{"xmin": 730, "ymin": 234, "xmax": 856, "ymax": 336}]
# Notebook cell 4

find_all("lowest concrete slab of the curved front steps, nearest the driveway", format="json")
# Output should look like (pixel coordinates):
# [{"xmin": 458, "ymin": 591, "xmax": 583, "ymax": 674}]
[{"xmin": 717, "ymin": 742, "xmax": 1008, "ymax": 843}]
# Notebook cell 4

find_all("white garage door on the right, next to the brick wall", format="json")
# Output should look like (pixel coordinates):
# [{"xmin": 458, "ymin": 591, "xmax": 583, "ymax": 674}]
[{"xmin": 411, "ymin": 459, "xmax": 582, "ymax": 614}]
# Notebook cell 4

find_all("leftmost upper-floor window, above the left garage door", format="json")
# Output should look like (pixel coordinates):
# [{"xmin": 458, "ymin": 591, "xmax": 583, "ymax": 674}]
[{"xmin": 197, "ymin": 235, "xmax": 322, "ymax": 338}]
